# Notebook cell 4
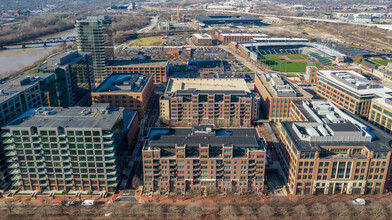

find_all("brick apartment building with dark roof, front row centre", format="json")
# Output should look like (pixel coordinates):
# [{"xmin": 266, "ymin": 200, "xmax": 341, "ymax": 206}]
[{"xmin": 142, "ymin": 125, "xmax": 266, "ymax": 195}]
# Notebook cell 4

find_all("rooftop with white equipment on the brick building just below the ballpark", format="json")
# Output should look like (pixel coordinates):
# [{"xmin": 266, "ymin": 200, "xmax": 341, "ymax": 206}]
[{"xmin": 255, "ymin": 73, "xmax": 313, "ymax": 98}]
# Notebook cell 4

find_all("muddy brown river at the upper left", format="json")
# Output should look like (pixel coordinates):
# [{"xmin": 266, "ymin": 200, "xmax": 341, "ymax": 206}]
[{"xmin": 0, "ymin": 29, "xmax": 76, "ymax": 77}]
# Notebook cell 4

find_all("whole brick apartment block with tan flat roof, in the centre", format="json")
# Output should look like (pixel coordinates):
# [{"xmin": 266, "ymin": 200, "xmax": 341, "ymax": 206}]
[{"xmin": 159, "ymin": 78, "xmax": 258, "ymax": 127}]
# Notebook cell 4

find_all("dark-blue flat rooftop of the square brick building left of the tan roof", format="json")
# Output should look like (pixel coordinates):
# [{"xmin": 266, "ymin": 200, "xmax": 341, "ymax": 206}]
[{"xmin": 94, "ymin": 73, "xmax": 152, "ymax": 93}]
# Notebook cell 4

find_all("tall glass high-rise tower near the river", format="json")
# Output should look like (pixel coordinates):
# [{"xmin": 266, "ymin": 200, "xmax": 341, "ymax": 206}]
[{"xmin": 76, "ymin": 15, "xmax": 114, "ymax": 85}]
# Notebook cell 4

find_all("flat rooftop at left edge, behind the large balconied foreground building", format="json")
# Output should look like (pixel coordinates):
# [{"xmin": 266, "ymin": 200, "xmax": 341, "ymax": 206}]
[{"xmin": 0, "ymin": 73, "xmax": 53, "ymax": 103}]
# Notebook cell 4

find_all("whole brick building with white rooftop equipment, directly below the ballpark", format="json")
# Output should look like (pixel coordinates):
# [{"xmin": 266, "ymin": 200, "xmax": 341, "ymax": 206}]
[{"xmin": 255, "ymin": 74, "xmax": 313, "ymax": 122}]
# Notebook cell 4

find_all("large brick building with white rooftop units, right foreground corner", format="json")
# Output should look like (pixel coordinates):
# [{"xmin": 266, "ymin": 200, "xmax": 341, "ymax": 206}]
[{"xmin": 278, "ymin": 100, "xmax": 392, "ymax": 194}]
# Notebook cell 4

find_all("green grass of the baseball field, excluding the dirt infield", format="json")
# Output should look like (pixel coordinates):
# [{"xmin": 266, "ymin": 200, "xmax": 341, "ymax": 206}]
[{"xmin": 259, "ymin": 55, "xmax": 321, "ymax": 72}]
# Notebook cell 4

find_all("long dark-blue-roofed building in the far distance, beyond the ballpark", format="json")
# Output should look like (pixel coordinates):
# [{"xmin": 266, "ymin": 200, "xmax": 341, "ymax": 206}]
[{"xmin": 196, "ymin": 15, "xmax": 262, "ymax": 25}]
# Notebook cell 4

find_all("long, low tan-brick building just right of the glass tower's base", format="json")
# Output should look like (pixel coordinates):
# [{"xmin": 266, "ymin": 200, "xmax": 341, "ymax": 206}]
[{"xmin": 105, "ymin": 59, "xmax": 169, "ymax": 84}]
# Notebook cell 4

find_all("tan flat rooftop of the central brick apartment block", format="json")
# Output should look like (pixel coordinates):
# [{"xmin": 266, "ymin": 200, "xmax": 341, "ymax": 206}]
[{"xmin": 165, "ymin": 78, "xmax": 250, "ymax": 94}]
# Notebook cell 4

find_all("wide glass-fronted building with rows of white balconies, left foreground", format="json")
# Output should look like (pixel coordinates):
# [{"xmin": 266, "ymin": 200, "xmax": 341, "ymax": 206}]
[{"xmin": 2, "ymin": 104, "xmax": 138, "ymax": 192}]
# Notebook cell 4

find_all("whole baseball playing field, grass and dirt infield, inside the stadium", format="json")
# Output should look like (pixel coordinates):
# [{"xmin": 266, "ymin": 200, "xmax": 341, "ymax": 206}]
[{"xmin": 259, "ymin": 54, "xmax": 321, "ymax": 72}]
